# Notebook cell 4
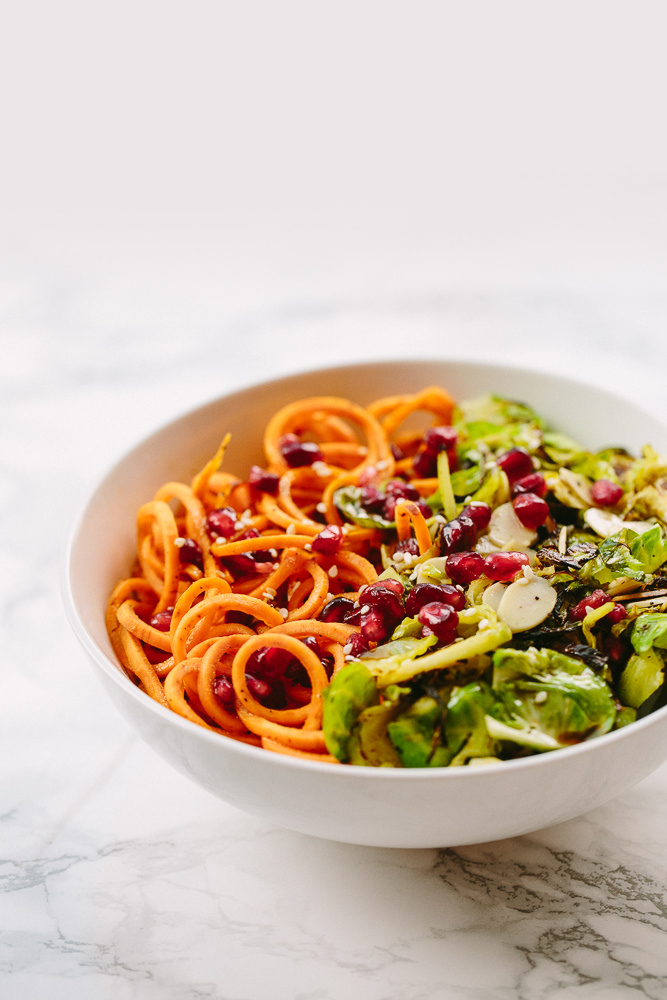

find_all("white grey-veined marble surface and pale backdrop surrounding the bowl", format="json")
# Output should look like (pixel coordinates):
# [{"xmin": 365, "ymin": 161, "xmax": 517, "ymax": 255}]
[{"xmin": 0, "ymin": 3, "xmax": 667, "ymax": 1000}]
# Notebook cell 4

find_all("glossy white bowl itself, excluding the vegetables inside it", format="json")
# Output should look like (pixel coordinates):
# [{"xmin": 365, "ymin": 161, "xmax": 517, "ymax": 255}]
[{"xmin": 64, "ymin": 360, "xmax": 667, "ymax": 847}]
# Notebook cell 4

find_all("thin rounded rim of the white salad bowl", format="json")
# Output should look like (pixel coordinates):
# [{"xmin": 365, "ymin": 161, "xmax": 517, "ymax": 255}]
[{"xmin": 60, "ymin": 357, "xmax": 667, "ymax": 783}]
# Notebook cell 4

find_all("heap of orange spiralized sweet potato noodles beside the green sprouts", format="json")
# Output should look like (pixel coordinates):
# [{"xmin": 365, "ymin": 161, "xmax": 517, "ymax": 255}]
[{"xmin": 106, "ymin": 387, "xmax": 453, "ymax": 763}]
